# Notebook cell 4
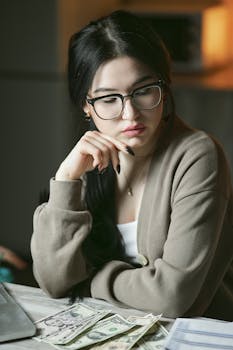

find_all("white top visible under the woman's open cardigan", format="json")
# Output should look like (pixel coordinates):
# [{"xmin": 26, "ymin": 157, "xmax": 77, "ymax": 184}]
[{"xmin": 117, "ymin": 221, "xmax": 138, "ymax": 259}]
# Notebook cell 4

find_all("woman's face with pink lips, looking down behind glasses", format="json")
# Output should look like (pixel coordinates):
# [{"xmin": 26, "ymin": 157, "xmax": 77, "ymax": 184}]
[{"xmin": 84, "ymin": 56, "xmax": 163, "ymax": 153}]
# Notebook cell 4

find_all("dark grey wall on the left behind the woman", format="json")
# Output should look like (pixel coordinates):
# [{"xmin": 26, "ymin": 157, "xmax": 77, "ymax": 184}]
[{"xmin": 0, "ymin": 0, "xmax": 71, "ymax": 257}]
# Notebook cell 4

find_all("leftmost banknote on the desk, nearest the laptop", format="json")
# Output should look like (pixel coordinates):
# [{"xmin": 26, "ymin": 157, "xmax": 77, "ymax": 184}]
[{"xmin": 35, "ymin": 303, "xmax": 109, "ymax": 344}]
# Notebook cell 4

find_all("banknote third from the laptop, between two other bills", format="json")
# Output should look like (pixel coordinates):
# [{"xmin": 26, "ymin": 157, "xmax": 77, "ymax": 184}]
[{"xmin": 92, "ymin": 314, "xmax": 161, "ymax": 350}]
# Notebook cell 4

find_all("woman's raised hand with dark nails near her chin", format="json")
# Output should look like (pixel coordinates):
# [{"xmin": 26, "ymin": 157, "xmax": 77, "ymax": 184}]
[{"xmin": 55, "ymin": 131, "xmax": 132, "ymax": 181}]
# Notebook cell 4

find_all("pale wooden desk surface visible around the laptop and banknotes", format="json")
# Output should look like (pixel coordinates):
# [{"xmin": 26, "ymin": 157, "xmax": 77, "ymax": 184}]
[{"xmin": 0, "ymin": 283, "xmax": 172, "ymax": 350}]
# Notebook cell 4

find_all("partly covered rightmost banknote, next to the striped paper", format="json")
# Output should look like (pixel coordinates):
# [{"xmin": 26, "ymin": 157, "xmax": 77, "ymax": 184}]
[{"xmin": 133, "ymin": 322, "xmax": 168, "ymax": 350}]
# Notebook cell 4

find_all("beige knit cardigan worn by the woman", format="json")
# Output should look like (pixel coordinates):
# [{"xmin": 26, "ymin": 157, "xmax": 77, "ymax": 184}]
[{"xmin": 31, "ymin": 118, "xmax": 233, "ymax": 320}]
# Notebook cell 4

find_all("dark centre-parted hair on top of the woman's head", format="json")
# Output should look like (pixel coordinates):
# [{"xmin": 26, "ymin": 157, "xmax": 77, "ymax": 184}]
[{"xmin": 68, "ymin": 10, "xmax": 171, "ymax": 112}]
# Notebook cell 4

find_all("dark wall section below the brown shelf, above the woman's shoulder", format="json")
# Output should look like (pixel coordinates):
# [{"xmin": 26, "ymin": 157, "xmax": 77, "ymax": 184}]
[{"xmin": 173, "ymin": 85, "xmax": 233, "ymax": 174}]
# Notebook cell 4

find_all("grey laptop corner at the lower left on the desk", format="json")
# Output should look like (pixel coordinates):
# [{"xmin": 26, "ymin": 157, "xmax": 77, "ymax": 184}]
[{"xmin": 0, "ymin": 283, "xmax": 36, "ymax": 342}]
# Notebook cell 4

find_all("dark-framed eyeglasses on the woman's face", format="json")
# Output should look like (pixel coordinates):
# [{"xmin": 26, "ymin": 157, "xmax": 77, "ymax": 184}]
[{"xmin": 86, "ymin": 80, "xmax": 164, "ymax": 120}]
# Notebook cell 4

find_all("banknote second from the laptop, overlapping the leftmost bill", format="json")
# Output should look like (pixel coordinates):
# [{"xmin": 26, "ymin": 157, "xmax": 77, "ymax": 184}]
[{"xmin": 53, "ymin": 314, "xmax": 135, "ymax": 350}]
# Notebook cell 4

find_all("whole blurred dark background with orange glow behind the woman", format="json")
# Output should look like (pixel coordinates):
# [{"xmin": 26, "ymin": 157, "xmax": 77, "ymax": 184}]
[{"xmin": 0, "ymin": 0, "xmax": 233, "ymax": 285}]
